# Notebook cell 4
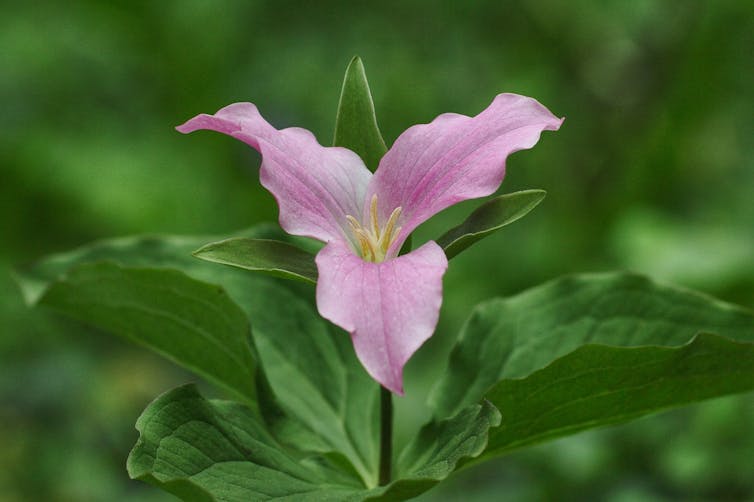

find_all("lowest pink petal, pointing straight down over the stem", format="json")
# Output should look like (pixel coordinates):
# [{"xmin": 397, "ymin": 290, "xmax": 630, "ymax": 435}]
[{"xmin": 317, "ymin": 241, "xmax": 448, "ymax": 395}]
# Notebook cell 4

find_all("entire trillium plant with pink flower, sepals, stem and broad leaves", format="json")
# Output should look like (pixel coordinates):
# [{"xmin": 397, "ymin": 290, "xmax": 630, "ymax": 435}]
[{"xmin": 17, "ymin": 58, "xmax": 754, "ymax": 501}]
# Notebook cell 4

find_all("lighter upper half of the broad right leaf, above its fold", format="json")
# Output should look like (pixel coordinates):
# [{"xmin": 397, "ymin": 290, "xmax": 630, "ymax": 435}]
[{"xmin": 430, "ymin": 273, "xmax": 754, "ymax": 417}]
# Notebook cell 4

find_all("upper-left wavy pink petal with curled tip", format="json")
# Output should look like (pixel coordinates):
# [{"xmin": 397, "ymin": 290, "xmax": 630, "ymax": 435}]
[{"xmin": 176, "ymin": 103, "xmax": 372, "ymax": 242}]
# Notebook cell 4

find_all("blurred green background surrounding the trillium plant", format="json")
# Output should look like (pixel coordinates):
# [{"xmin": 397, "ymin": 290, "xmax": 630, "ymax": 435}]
[{"xmin": 0, "ymin": 0, "xmax": 754, "ymax": 502}]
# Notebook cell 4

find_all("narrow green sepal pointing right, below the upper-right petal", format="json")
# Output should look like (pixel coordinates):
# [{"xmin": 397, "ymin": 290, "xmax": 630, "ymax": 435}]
[{"xmin": 437, "ymin": 190, "xmax": 547, "ymax": 259}]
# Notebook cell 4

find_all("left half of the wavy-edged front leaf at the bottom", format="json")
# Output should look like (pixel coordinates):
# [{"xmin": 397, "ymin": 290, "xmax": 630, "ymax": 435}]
[{"xmin": 127, "ymin": 386, "xmax": 360, "ymax": 501}]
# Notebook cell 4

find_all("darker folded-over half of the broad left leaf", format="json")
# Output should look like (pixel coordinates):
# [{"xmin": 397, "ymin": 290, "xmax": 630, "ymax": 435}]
[{"xmin": 40, "ymin": 263, "xmax": 256, "ymax": 403}]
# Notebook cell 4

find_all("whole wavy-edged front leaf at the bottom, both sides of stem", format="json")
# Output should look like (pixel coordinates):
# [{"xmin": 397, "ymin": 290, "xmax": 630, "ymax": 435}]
[{"xmin": 127, "ymin": 386, "xmax": 500, "ymax": 502}]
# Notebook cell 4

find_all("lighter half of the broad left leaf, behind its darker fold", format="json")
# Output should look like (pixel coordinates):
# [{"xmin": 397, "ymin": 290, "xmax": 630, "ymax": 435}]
[{"xmin": 17, "ymin": 226, "xmax": 379, "ymax": 484}]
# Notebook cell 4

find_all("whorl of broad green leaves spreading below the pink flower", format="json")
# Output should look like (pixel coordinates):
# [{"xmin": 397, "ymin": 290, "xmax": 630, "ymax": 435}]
[{"xmin": 19, "ymin": 227, "xmax": 754, "ymax": 500}]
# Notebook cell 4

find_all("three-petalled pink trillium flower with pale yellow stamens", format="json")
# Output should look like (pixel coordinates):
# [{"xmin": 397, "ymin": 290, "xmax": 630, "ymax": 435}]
[{"xmin": 177, "ymin": 94, "xmax": 562, "ymax": 395}]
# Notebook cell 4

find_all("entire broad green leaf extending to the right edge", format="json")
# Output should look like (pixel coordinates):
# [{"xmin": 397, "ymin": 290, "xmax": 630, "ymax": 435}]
[{"xmin": 430, "ymin": 273, "xmax": 754, "ymax": 458}]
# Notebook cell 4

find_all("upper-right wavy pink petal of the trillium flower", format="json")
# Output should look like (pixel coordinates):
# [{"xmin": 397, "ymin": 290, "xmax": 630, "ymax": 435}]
[{"xmin": 364, "ymin": 94, "xmax": 563, "ymax": 255}]
